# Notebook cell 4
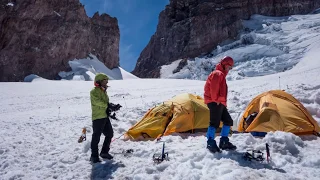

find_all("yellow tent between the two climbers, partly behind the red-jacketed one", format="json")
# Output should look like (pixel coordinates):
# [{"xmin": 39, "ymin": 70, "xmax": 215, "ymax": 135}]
[{"xmin": 125, "ymin": 93, "xmax": 209, "ymax": 140}]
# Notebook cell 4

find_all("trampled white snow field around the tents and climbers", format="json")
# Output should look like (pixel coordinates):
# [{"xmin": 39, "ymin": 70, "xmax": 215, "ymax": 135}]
[{"xmin": 0, "ymin": 15, "xmax": 320, "ymax": 180}]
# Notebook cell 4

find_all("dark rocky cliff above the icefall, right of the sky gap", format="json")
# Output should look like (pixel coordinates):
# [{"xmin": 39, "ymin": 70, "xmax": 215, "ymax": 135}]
[{"xmin": 133, "ymin": 0, "xmax": 320, "ymax": 78}]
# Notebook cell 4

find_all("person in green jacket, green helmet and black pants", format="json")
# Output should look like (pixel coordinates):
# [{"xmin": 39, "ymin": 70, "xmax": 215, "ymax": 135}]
[{"xmin": 90, "ymin": 73, "xmax": 113, "ymax": 163}]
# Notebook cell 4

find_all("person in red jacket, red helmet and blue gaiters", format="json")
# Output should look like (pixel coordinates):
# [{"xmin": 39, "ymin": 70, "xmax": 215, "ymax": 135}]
[{"xmin": 204, "ymin": 56, "xmax": 237, "ymax": 153}]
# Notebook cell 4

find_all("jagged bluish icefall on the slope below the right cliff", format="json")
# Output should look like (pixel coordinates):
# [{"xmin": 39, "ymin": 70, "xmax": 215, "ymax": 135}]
[{"xmin": 161, "ymin": 11, "xmax": 320, "ymax": 80}]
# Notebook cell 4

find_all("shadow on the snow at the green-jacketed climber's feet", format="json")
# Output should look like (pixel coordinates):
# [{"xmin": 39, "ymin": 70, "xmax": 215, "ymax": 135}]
[{"xmin": 90, "ymin": 160, "xmax": 125, "ymax": 180}]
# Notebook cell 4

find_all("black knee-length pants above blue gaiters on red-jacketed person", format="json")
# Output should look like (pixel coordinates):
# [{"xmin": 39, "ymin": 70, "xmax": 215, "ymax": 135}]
[{"xmin": 208, "ymin": 102, "xmax": 233, "ymax": 129}]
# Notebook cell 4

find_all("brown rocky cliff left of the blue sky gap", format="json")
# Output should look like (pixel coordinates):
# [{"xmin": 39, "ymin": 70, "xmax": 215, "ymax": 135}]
[{"xmin": 0, "ymin": 0, "xmax": 120, "ymax": 81}]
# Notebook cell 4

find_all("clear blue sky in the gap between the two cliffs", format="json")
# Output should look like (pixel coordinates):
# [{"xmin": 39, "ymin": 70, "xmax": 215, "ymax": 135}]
[{"xmin": 80, "ymin": 0, "xmax": 169, "ymax": 72}]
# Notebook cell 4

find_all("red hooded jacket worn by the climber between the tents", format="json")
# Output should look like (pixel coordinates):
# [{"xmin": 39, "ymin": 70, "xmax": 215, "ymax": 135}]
[{"xmin": 204, "ymin": 63, "xmax": 228, "ymax": 107}]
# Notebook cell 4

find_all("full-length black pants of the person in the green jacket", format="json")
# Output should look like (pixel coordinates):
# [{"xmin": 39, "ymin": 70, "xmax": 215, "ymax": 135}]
[{"xmin": 91, "ymin": 118, "xmax": 113, "ymax": 157}]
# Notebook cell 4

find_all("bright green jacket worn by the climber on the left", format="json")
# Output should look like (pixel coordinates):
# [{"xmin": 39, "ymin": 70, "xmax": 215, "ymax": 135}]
[{"xmin": 90, "ymin": 87, "xmax": 109, "ymax": 120}]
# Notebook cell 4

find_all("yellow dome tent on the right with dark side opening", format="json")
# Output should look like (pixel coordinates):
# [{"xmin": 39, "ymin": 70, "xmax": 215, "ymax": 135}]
[{"xmin": 238, "ymin": 90, "xmax": 320, "ymax": 135}]
